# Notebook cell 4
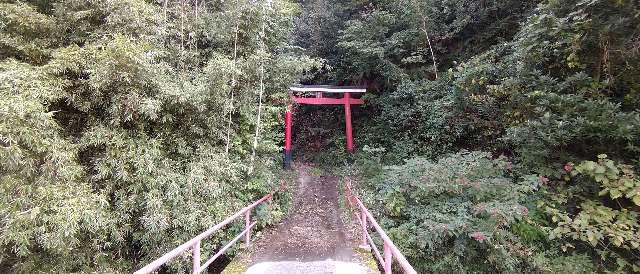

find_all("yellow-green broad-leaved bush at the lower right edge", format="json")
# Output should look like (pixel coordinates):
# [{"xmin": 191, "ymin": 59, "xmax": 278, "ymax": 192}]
[{"xmin": 539, "ymin": 155, "xmax": 640, "ymax": 272}]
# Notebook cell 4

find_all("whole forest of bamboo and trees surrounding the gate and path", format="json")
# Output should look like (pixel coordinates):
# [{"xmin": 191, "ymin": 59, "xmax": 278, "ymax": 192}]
[{"xmin": 0, "ymin": 0, "xmax": 640, "ymax": 273}]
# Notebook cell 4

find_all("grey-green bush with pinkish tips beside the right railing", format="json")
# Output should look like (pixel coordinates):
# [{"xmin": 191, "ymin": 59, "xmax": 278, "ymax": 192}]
[{"xmin": 370, "ymin": 152, "xmax": 539, "ymax": 272}]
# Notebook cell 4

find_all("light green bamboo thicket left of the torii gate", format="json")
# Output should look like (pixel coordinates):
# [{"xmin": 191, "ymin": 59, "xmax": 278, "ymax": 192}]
[{"xmin": 0, "ymin": 0, "xmax": 316, "ymax": 273}]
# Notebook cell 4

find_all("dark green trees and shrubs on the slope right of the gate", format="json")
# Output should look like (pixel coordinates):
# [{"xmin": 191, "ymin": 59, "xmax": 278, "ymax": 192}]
[{"xmin": 299, "ymin": 0, "xmax": 640, "ymax": 272}]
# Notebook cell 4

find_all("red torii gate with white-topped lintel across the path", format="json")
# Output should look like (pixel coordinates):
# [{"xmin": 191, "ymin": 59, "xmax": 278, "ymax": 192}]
[{"xmin": 284, "ymin": 85, "xmax": 367, "ymax": 168}]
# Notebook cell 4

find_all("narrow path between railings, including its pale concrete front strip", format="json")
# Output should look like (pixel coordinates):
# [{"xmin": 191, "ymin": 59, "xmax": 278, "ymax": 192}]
[{"xmin": 223, "ymin": 164, "xmax": 378, "ymax": 274}]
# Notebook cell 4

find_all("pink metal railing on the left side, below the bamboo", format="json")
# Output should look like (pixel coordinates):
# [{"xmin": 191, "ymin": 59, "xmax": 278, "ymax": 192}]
[{"xmin": 134, "ymin": 191, "xmax": 277, "ymax": 274}]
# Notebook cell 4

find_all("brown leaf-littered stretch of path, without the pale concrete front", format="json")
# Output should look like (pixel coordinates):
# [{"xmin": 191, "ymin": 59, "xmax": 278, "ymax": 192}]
[{"xmin": 249, "ymin": 164, "xmax": 354, "ymax": 263}]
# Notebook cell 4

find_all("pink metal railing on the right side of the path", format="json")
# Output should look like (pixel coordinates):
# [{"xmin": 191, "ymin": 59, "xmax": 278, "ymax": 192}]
[{"xmin": 346, "ymin": 180, "xmax": 418, "ymax": 274}]
